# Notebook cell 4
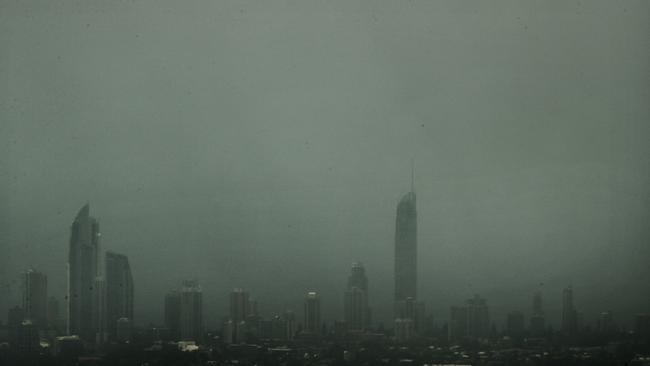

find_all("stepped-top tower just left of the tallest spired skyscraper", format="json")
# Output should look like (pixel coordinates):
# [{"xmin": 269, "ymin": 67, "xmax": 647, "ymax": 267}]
[{"xmin": 343, "ymin": 262, "xmax": 370, "ymax": 330}]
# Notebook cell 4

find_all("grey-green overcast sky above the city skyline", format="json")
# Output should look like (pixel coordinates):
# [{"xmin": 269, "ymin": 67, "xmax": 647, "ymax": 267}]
[{"xmin": 0, "ymin": 0, "xmax": 650, "ymax": 328}]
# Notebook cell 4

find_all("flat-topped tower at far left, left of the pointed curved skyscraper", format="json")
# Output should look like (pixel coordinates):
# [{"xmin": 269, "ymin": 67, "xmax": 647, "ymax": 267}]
[{"xmin": 23, "ymin": 269, "xmax": 48, "ymax": 329}]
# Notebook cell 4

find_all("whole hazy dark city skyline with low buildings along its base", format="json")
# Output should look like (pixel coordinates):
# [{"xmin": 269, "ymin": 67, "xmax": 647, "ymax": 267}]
[{"xmin": 0, "ymin": 197, "xmax": 650, "ymax": 364}]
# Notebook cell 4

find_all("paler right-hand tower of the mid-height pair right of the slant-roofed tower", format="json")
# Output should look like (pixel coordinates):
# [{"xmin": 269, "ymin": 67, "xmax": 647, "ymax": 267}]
[{"xmin": 180, "ymin": 281, "xmax": 203, "ymax": 341}]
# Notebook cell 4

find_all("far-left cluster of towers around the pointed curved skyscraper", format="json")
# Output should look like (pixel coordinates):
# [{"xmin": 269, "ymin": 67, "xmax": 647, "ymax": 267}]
[{"xmin": 8, "ymin": 204, "xmax": 134, "ymax": 350}]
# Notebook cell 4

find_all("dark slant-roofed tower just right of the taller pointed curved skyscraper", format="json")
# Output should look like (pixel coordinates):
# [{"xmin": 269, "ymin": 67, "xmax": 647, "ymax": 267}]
[{"xmin": 106, "ymin": 252, "xmax": 133, "ymax": 339}]
